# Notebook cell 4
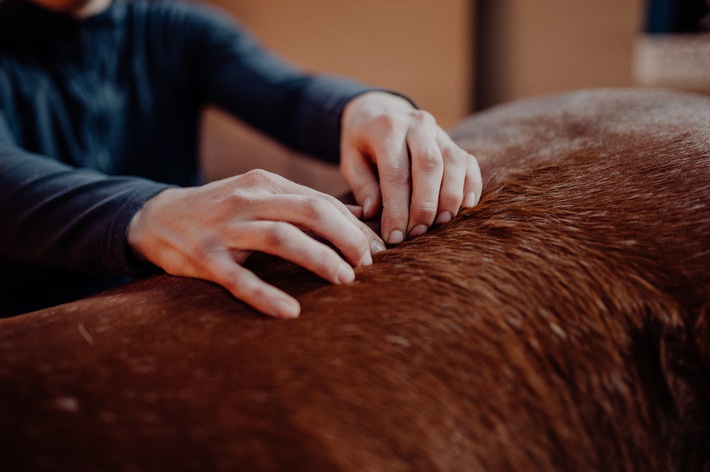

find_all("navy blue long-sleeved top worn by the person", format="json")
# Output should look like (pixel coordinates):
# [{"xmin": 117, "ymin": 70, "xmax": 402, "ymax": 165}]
[{"xmin": 0, "ymin": 0, "xmax": 376, "ymax": 316}]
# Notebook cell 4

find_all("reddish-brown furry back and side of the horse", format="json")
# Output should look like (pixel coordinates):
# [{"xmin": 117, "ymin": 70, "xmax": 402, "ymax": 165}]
[{"xmin": 0, "ymin": 90, "xmax": 710, "ymax": 472}]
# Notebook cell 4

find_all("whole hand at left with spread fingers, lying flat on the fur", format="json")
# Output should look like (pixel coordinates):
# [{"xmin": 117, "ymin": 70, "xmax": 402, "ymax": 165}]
[{"xmin": 128, "ymin": 170, "xmax": 385, "ymax": 318}]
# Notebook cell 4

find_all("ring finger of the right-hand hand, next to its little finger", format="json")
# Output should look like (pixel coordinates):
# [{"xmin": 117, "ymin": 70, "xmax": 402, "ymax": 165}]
[{"xmin": 435, "ymin": 130, "xmax": 473, "ymax": 224}]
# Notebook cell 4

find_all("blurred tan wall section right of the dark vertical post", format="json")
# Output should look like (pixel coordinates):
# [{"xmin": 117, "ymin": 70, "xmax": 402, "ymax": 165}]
[{"xmin": 476, "ymin": 0, "xmax": 644, "ymax": 107}]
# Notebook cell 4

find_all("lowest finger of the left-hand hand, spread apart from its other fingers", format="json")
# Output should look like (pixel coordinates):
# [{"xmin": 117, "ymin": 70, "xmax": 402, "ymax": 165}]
[{"xmin": 197, "ymin": 252, "xmax": 301, "ymax": 319}]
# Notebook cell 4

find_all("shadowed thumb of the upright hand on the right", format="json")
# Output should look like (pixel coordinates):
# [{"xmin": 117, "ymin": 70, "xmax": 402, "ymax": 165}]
[{"xmin": 340, "ymin": 148, "xmax": 382, "ymax": 219}]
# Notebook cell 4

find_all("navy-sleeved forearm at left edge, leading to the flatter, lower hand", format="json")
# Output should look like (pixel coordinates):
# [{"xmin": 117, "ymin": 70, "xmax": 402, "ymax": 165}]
[{"xmin": 0, "ymin": 147, "xmax": 166, "ymax": 274}]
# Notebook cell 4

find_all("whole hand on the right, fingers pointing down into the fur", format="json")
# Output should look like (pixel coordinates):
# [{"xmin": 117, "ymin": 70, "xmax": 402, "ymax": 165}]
[{"xmin": 340, "ymin": 92, "xmax": 482, "ymax": 244}]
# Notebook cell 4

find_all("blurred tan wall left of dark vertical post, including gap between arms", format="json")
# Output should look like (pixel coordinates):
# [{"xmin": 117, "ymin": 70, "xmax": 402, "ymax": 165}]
[{"xmin": 203, "ymin": 0, "xmax": 473, "ymax": 193}]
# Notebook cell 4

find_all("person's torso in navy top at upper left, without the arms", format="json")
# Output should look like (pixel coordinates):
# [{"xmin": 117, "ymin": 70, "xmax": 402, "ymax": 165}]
[{"xmin": 0, "ymin": 3, "xmax": 206, "ymax": 185}]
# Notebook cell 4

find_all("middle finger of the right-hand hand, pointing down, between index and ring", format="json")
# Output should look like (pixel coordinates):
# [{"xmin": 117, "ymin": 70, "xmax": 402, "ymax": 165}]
[{"xmin": 407, "ymin": 111, "xmax": 444, "ymax": 240}]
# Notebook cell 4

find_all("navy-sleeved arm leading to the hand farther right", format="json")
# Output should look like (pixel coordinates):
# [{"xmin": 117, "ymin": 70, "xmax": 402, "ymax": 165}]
[{"xmin": 182, "ymin": 2, "xmax": 371, "ymax": 162}]
